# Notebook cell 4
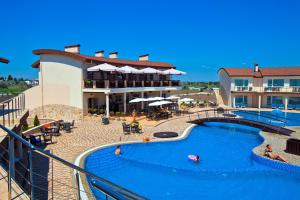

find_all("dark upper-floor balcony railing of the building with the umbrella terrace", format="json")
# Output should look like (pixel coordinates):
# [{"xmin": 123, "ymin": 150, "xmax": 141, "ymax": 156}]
[{"xmin": 84, "ymin": 80, "xmax": 180, "ymax": 88}]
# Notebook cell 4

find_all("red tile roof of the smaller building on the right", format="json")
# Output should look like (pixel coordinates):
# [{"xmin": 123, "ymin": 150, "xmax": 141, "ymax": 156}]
[{"xmin": 220, "ymin": 67, "xmax": 300, "ymax": 77}]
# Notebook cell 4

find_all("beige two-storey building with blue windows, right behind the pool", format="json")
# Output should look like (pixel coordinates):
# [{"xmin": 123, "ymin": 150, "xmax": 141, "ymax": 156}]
[{"xmin": 218, "ymin": 65, "xmax": 300, "ymax": 109}]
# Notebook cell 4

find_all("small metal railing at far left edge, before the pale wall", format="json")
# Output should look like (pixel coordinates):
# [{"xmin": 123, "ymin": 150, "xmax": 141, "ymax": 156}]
[{"xmin": 0, "ymin": 93, "xmax": 25, "ymax": 126}]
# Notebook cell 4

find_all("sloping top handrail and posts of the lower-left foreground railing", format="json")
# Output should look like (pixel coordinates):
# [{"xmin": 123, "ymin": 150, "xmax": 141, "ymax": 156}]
[{"xmin": 0, "ymin": 124, "xmax": 147, "ymax": 200}]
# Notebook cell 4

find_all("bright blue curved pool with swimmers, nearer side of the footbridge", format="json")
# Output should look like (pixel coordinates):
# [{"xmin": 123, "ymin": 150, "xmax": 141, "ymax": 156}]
[{"xmin": 85, "ymin": 123, "xmax": 300, "ymax": 200}]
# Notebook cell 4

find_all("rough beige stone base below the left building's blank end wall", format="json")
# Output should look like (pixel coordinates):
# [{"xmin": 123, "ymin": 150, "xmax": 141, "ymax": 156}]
[{"xmin": 29, "ymin": 104, "xmax": 83, "ymax": 121}]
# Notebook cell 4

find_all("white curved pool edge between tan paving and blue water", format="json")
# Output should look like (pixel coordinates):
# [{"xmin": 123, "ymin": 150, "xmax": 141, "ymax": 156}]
[{"xmin": 73, "ymin": 124, "xmax": 197, "ymax": 200}]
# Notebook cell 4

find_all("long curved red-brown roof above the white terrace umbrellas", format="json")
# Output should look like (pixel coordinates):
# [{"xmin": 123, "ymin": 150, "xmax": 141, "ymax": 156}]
[{"xmin": 31, "ymin": 49, "xmax": 175, "ymax": 69}]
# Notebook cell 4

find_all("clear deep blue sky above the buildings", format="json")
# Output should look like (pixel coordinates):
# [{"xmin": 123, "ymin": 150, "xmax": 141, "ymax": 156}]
[{"xmin": 0, "ymin": 0, "xmax": 300, "ymax": 81}]
